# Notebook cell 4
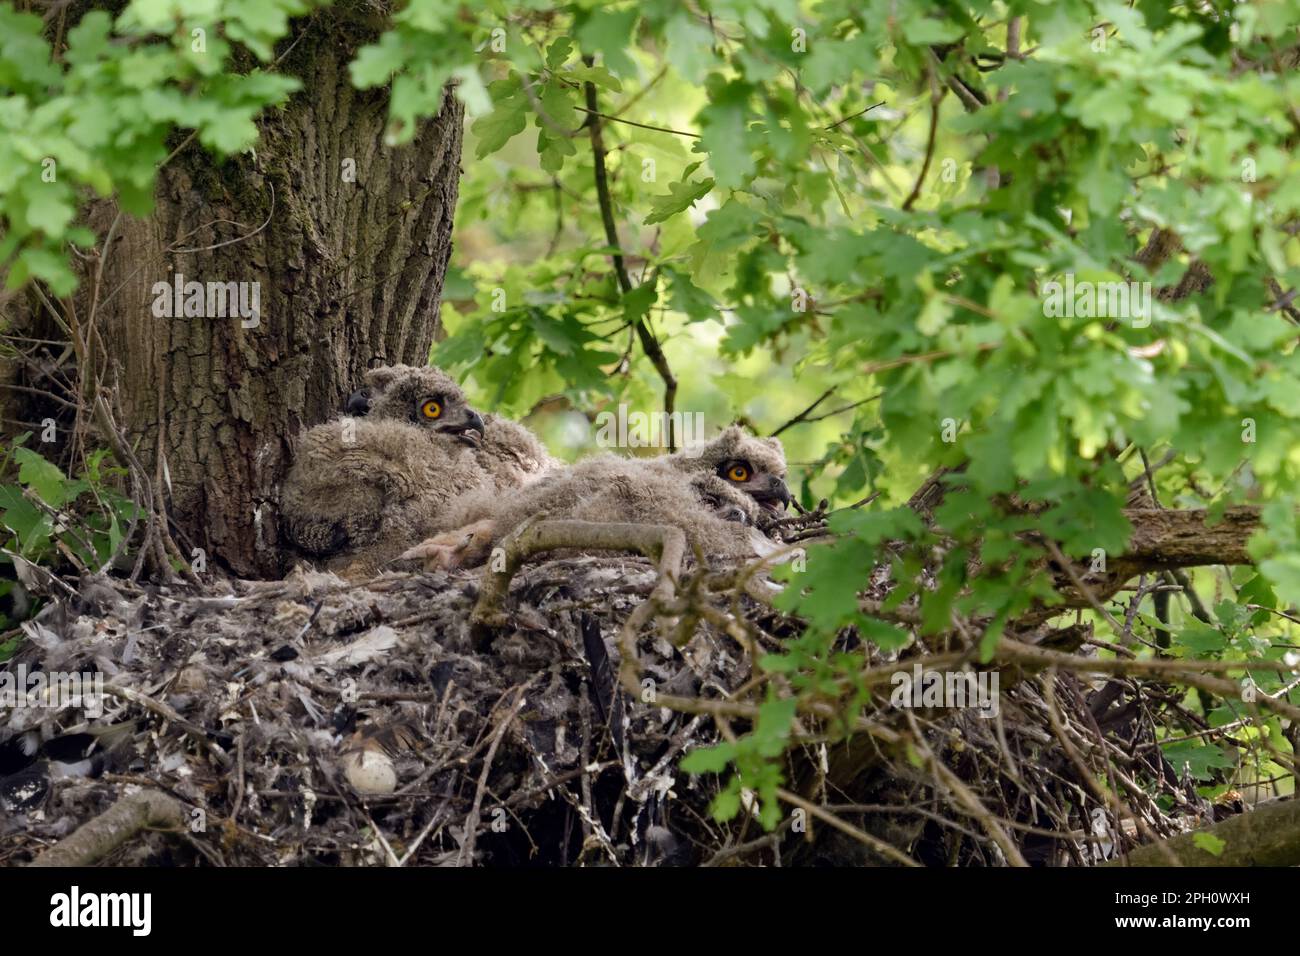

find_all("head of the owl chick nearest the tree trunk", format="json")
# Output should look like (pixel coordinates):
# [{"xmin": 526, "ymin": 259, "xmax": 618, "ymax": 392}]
[{"xmin": 347, "ymin": 365, "xmax": 484, "ymax": 445}]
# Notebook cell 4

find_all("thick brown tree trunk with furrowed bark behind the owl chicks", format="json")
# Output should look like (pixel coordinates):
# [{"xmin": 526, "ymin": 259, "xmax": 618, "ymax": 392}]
[{"xmin": 13, "ymin": 13, "xmax": 463, "ymax": 576}]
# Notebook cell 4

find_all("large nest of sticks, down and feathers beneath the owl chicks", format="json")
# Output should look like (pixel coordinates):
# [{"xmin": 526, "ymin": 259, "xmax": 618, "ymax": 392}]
[{"xmin": 0, "ymin": 528, "xmax": 1279, "ymax": 866}]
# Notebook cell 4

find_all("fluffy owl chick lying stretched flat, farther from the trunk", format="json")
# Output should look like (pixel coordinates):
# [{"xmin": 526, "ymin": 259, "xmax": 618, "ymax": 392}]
[{"xmin": 403, "ymin": 428, "xmax": 790, "ymax": 567}]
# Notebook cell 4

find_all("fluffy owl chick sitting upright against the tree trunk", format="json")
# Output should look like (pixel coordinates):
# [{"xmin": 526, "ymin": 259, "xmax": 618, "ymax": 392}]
[{"xmin": 281, "ymin": 365, "xmax": 551, "ymax": 574}]
